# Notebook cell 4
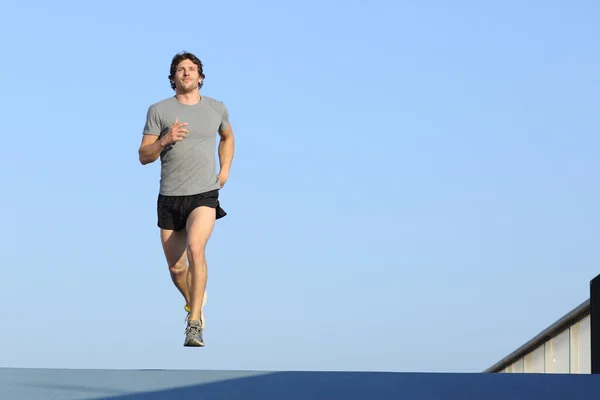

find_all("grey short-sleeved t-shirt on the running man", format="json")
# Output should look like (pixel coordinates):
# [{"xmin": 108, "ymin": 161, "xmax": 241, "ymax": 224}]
[{"xmin": 143, "ymin": 96, "xmax": 229, "ymax": 196}]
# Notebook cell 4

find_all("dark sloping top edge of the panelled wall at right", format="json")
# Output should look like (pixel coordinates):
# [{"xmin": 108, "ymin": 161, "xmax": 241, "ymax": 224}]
[{"xmin": 483, "ymin": 299, "xmax": 590, "ymax": 373}]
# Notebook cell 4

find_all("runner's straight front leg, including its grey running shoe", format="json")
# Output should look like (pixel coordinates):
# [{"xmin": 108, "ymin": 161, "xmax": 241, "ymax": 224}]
[{"xmin": 184, "ymin": 206, "xmax": 216, "ymax": 346}]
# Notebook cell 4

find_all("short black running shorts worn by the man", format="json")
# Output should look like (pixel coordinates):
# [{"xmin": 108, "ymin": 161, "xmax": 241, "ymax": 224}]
[{"xmin": 156, "ymin": 189, "xmax": 227, "ymax": 231}]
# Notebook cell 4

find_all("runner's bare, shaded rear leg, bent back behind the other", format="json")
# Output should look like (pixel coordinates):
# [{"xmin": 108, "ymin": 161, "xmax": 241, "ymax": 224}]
[{"xmin": 160, "ymin": 229, "xmax": 190, "ymax": 304}]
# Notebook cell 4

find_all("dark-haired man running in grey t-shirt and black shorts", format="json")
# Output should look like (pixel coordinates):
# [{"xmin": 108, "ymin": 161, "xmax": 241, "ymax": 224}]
[{"xmin": 139, "ymin": 52, "xmax": 234, "ymax": 347}]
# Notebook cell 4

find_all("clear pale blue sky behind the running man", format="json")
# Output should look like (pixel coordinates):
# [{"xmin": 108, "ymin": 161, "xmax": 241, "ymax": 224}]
[{"xmin": 0, "ymin": 1, "xmax": 600, "ymax": 372}]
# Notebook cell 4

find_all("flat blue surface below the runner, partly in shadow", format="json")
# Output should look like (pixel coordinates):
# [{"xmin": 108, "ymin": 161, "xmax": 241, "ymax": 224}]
[{"xmin": 0, "ymin": 368, "xmax": 600, "ymax": 400}]
